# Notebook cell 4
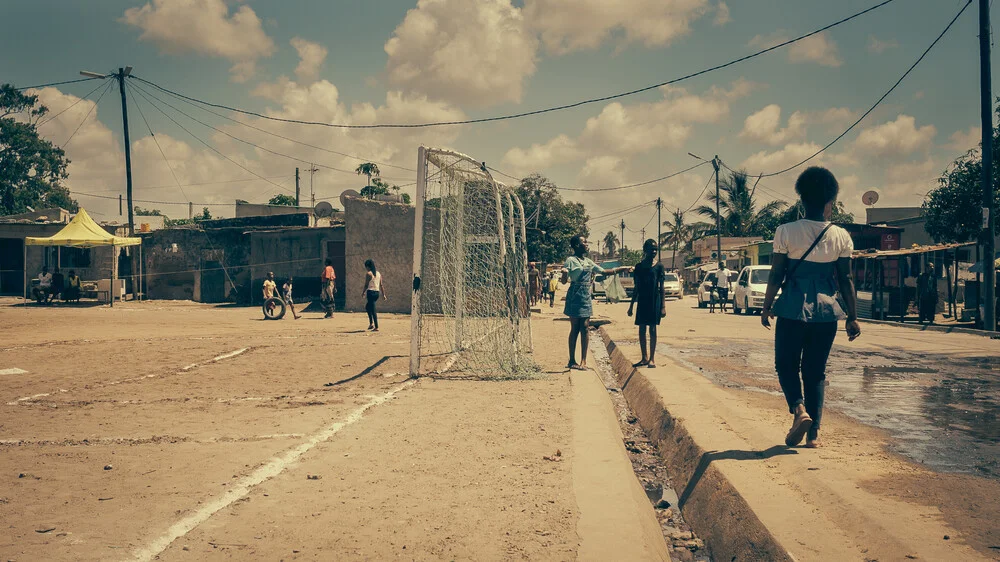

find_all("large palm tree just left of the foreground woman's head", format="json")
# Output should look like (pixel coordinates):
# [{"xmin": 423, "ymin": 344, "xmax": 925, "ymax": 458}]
[{"xmin": 696, "ymin": 166, "xmax": 786, "ymax": 238}]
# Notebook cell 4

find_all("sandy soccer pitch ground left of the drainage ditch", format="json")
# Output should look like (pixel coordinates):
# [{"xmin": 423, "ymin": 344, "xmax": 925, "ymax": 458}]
[{"xmin": 0, "ymin": 300, "xmax": 666, "ymax": 560}]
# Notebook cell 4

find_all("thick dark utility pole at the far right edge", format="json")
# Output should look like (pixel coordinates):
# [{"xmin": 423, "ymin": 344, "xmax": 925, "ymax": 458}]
[{"xmin": 979, "ymin": 0, "xmax": 997, "ymax": 332}]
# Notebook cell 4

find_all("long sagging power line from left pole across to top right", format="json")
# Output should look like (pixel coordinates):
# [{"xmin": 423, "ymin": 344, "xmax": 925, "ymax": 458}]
[{"xmin": 132, "ymin": 0, "xmax": 895, "ymax": 129}]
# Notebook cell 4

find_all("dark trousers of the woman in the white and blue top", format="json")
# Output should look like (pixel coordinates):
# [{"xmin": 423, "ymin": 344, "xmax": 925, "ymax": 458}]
[{"xmin": 774, "ymin": 318, "xmax": 837, "ymax": 439}]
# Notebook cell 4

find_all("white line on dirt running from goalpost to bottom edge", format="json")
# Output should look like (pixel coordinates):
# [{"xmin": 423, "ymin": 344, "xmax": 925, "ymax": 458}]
[{"xmin": 132, "ymin": 380, "xmax": 416, "ymax": 560}]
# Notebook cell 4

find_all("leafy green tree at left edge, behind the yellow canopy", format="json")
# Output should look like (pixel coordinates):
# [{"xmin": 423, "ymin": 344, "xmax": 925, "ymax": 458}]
[{"xmin": 0, "ymin": 84, "xmax": 79, "ymax": 215}]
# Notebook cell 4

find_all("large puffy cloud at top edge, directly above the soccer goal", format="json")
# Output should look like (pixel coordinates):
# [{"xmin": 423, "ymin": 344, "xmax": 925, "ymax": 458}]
[{"xmin": 385, "ymin": 0, "xmax": 538, "ymax": 107}]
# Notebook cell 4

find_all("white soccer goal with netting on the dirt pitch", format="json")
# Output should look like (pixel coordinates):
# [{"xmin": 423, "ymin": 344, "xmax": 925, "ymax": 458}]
[{"xmin": 410, "ymin": 147, "xmax": 534, "ymax": 378}]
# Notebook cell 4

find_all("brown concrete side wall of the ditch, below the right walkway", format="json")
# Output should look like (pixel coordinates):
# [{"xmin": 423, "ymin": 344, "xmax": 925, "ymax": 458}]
[{"xmin": 598, "ymin": 327, "xmax": 794, "ymax": 562}]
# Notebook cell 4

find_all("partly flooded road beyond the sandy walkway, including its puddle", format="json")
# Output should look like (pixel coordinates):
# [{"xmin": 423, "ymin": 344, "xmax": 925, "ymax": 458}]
[{"xmin": 608, "ymin": 297, "xmax": 1000, "ymax": 478}]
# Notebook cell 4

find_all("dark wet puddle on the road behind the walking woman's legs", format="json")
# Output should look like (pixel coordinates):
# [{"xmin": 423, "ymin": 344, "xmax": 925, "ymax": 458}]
[{"xmin": 656, "ymin": 340, "xmax": 1000, "ymax": 478}]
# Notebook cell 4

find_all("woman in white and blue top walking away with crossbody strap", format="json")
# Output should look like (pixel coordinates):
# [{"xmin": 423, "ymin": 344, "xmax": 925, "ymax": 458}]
[{"xmin": 760, "ymin": 166, "xmax": 861, "ymax": 448}]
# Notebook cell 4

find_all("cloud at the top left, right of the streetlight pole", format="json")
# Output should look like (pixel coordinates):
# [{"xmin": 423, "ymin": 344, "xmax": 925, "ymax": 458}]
[{"xmin": 120, "ymin": 0, "xmax": 274, "ymax": 81}]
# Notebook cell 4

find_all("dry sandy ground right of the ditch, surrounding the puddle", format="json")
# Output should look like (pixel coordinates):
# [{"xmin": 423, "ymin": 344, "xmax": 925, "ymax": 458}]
[{"xmin": 595, "ymin": 299, "xmax": 1000, "ymax": 560}]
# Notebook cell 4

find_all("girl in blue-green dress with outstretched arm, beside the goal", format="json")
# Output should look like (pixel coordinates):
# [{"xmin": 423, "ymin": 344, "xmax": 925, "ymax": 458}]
[{"xmin": 563, "ymin": 236, "xmax": 629, "ymax": 371}]
